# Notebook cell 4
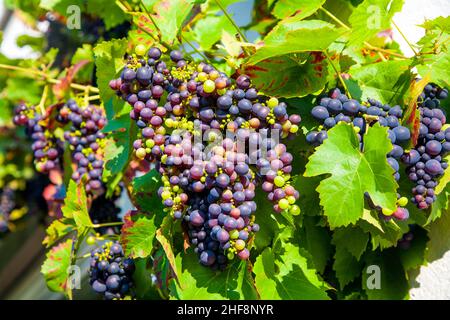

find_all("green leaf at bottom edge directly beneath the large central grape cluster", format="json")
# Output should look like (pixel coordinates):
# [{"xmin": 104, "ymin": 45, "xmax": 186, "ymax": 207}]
[{"xmin": 171, "ymin": 251, "xmax": 258, "ymax": 300}]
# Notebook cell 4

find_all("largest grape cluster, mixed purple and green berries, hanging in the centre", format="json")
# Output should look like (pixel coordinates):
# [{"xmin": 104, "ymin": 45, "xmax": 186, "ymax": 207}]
[{"xmin": 110, "ymin": 46, "xmax": 301, "ymax": 268}]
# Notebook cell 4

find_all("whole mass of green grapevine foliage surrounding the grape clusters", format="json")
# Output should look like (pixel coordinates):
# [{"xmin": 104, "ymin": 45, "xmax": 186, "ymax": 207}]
[{"xmin": 0, "ymin": 0, "xmax": 450, "ymax": 300}]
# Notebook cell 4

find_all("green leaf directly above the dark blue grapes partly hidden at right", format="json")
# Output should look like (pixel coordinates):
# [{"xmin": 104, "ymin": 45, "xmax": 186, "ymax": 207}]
[{"xmin": 348, "ymin": 60, "xmax": 413, "ymax": 104}]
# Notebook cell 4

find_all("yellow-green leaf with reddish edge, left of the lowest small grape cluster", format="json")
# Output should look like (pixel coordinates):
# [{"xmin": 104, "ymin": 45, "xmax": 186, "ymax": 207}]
[{"xmin": 41, "ymin": 239, "xmax": 72, "ymax": 292}]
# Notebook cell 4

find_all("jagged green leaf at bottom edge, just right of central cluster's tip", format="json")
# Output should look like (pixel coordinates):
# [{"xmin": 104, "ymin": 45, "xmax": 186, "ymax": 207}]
[{"xmin": 253, "ymin": 243, "xmax": 329, "ymax": 300}]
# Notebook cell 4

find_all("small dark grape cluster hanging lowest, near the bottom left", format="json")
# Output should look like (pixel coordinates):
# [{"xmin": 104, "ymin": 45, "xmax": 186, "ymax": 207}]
[{"xmin": 89, "ymin": 241, "xmax": 135, "ymax": 300}]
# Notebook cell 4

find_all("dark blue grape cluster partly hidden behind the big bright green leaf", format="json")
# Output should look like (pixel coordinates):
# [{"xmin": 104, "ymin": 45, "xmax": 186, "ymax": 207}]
[{"xmin": 306, "ymin": 88, "xmax": 411, "ymax": 220}]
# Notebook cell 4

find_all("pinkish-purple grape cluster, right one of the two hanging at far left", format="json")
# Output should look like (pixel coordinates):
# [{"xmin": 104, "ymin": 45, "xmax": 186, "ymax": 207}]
[{"xmin": 57, "ymin": 100, "xmax": 106, "ymax": 194}]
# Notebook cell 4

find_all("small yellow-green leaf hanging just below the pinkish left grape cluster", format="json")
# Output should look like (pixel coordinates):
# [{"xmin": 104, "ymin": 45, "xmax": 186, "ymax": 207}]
[{"xmin": 61, "ymin": 180, "xmax": 92, "ymax": 234}]
